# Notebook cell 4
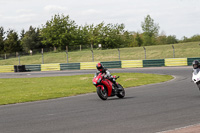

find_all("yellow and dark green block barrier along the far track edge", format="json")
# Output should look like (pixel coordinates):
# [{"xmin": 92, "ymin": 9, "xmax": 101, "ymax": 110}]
[{"xmin": 0, "ymin": 57, "xmax": 200, "ymax": 73}]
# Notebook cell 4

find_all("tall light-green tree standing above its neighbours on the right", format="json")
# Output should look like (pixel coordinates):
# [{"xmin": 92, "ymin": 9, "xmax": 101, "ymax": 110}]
[{"xmin": 141, "ymin": 15, "xmax": 160, "ymax": 45}]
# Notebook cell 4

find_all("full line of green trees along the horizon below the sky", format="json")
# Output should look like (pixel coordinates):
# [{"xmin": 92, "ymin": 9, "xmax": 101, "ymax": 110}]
[{"xmin": 0, "ymin": 14, "xmax": 200, "ymax": 54}]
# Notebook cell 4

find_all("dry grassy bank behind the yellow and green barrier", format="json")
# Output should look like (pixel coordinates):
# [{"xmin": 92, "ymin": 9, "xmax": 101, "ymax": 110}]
[{"xmin": 0, "ymin": 42, "xmax": 200, "ymax": 65}]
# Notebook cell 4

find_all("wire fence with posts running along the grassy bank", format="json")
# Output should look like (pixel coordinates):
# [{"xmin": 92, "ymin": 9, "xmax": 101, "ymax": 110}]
[{"xmin": 0, "ymin": 43, "xmax": 200, "ymax": 65}]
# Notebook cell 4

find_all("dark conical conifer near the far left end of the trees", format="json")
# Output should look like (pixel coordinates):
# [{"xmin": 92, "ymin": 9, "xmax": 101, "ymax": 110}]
[{"xmin": 4, "ymin": 30, "xmax": 22, "ymax": 53}]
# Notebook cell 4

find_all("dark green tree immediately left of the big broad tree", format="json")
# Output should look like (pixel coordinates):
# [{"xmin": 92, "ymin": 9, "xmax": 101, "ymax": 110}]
[{"xmin": 21, "ymin": 26, "xmax": 42, "ymax": 52}]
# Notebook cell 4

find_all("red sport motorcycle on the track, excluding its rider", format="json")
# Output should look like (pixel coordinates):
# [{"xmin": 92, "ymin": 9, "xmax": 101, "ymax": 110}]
[{"xmin": 92, "ymin": 73, "xmax": 125, "ymax": 100}]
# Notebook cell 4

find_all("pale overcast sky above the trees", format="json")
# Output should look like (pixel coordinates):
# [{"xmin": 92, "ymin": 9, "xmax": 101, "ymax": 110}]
[{"xmin": 0, "ymin": 0, "xmax": 200, "ymax": 39}]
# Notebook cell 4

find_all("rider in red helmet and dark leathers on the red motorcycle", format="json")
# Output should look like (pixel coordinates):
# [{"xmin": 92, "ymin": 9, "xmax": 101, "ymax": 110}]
[{"xmin": 96, "ymin": 63, "xmax": 121, "ymax": 90}]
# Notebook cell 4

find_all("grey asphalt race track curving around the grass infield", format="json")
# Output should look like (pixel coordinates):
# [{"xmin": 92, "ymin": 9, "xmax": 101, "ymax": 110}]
[{"xmin": 0, "ymin": 67, "xmax": 200, "ymax": 133}]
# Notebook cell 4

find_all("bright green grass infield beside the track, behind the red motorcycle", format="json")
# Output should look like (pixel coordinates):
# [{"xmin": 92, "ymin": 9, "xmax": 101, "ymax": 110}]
[{"xmin": 0, "ymin": 73, "xmax": 173, "ymax": 105}]
